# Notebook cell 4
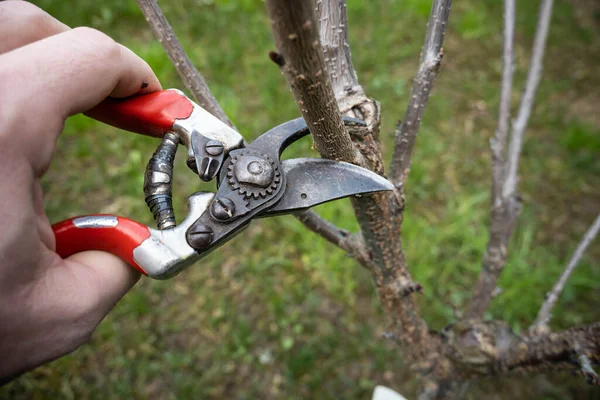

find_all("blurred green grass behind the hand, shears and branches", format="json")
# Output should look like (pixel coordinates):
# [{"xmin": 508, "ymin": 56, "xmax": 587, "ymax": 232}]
[{"xmin": 0, "ymin": 0, "xmax": 600, "ymax": 399}]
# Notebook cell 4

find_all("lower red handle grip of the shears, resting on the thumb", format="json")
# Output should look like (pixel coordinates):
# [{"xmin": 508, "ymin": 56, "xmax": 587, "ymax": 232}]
[{"xmin": 52, "ymin": 215, "xmax": 150, "ymax": 275}]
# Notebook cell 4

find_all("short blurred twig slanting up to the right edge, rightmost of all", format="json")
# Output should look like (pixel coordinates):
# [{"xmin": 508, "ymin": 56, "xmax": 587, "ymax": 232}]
[{"xmin": 531, "ymin": 214, "xmax": 600, "ymax": 331}]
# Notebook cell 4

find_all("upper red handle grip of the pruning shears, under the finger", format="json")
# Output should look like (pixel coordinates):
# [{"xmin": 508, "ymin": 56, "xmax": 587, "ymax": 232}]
[{"xmin": 86, "ymin": 90, "xmax": 194, "ymax": 137}]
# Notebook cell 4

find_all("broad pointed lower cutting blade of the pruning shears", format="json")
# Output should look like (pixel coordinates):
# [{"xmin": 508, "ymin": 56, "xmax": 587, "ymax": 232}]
[{"xmin": 260, "ymin": 158, "xmax": 394, "ymax": 216}]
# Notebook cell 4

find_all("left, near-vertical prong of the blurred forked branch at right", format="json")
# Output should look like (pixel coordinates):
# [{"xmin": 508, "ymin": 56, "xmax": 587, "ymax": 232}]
[{"xmin": 490, "ymin": 0, "xmax": 515, "ymax": 208}]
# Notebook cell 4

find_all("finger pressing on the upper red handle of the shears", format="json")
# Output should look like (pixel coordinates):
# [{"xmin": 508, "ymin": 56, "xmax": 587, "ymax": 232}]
[{"xmin": 0, "ymin": 27, "xmax": 160, "ymax": 117}]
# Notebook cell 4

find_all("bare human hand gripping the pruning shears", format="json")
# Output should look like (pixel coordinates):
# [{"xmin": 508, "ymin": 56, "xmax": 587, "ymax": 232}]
[{"xmin": 0, "ymin": 1, "xmax": 160, "ymax": 383}]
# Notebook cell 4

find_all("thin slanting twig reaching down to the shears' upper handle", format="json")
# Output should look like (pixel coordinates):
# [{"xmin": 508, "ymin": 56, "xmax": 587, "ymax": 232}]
[{"xmin": 137, "ymin": 0, "xmax": 233, "ymax": 126}]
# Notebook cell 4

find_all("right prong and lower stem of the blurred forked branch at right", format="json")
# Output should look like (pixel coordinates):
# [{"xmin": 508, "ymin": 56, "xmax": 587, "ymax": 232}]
[{"xmin": 467, "ymin": 0, "xmax": 553, "ymax": 318}]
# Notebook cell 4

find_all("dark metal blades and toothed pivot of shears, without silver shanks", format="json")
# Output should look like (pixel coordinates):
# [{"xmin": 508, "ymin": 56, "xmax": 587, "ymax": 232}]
[{"xmin": 186, "ymin": 118, "xmax": 393, "ymax": 253}]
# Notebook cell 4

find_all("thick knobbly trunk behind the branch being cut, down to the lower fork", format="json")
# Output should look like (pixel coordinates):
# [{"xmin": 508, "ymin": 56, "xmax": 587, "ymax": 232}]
[{"xmin": 317, "ymin": 0, "xmax": 443, "ymax": 378}]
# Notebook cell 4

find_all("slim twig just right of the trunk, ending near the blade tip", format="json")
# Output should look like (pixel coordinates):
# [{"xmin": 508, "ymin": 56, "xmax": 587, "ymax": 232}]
[{"xmin": 389, "ymin": 0, "xmax": 452, "ymax": 186}]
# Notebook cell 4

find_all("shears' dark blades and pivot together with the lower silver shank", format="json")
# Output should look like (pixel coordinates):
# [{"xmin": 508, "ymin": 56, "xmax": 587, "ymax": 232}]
[{"xmin": 133, "ymin": 114, "xmax": 393, "ymax": 279}]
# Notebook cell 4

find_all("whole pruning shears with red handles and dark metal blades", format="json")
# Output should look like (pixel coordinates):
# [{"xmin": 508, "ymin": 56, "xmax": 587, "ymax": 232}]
[{"xmin": 52, "ymin": 89, "xmax": 393, "ymax": 279}]
